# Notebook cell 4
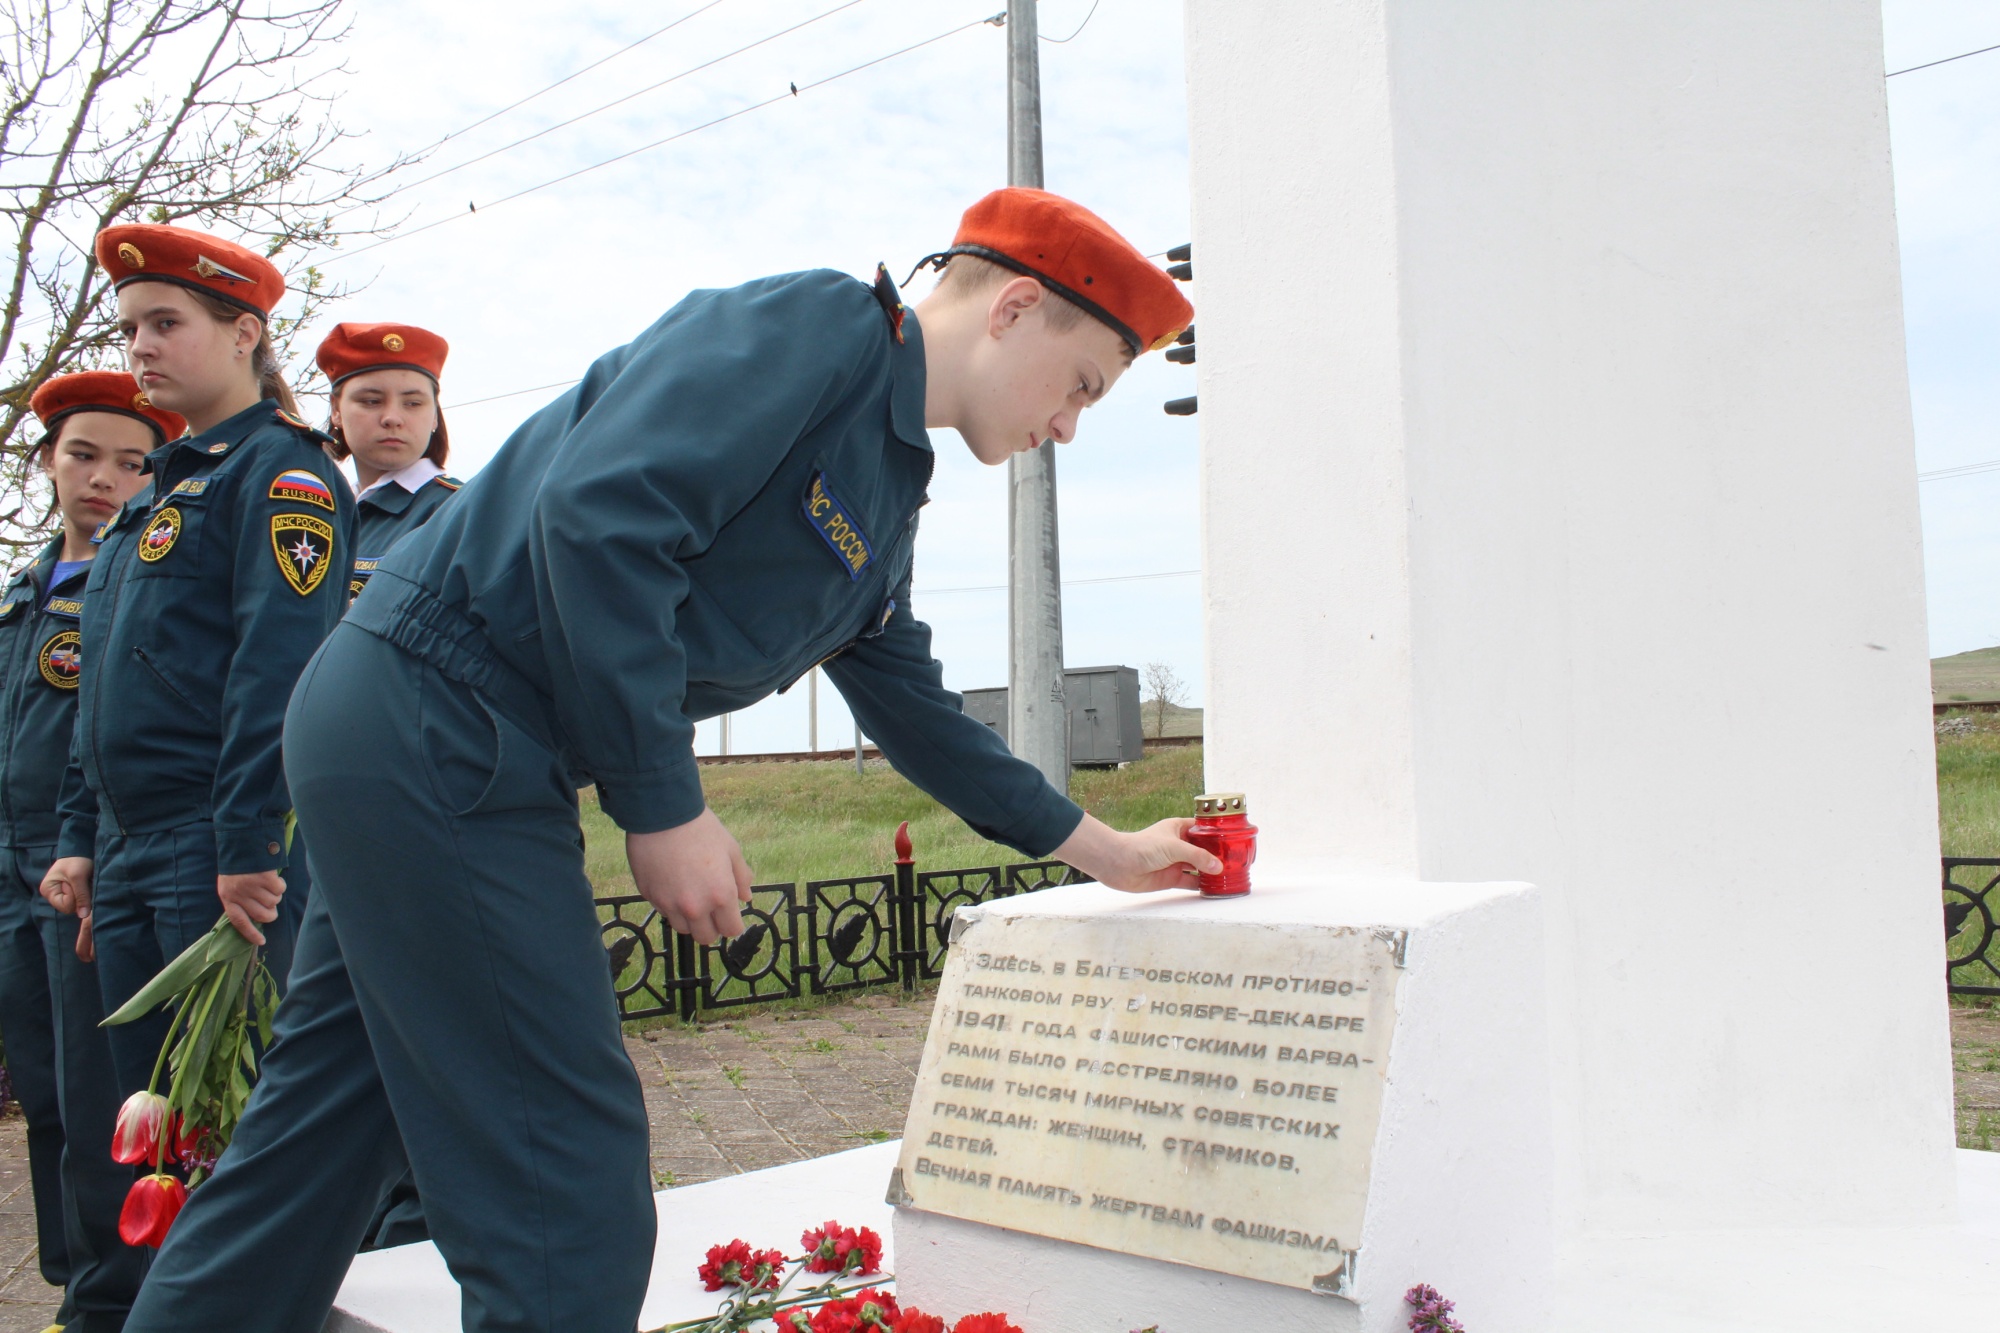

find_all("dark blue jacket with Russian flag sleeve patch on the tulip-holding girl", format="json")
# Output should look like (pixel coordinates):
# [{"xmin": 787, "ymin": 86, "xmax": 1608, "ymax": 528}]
[{"xmin": 60, "ymin": 398, "xmax": 354, "ymax": 875}]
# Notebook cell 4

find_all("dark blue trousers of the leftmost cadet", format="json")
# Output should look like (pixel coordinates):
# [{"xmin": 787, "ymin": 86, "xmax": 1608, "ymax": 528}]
[{"xmin": 0, "ymin": 847, "xmax": 150, "ymax": 1333}]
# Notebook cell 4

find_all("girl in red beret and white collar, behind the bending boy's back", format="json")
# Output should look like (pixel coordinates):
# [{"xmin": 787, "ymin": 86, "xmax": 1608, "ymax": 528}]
[{"xmin": 318, "ymin": 324, "xmax": 460, "ymax": 596}]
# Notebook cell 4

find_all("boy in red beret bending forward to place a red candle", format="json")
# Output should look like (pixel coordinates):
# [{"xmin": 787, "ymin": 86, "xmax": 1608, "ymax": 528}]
[{"xmin": 126, "ymin": 190, "xmax": 1220, "ymax": 1333}]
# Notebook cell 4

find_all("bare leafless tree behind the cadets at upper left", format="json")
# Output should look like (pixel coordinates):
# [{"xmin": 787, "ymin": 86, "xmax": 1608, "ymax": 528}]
[{"xmin": 0, "ymin": 0, "xmax": 406, "ymax": 550}]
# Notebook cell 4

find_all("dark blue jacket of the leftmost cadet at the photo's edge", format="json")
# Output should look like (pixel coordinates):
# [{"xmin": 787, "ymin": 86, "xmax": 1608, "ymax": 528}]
[{"xmin": 0, "ymin": 536, "xmax": 88, "ymax": 847}]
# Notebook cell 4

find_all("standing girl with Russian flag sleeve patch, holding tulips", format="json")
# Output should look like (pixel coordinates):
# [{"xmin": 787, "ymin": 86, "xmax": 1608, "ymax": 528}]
[{"xmin": 44, "ymin": 224, "xmax": 354, "ymax": 1095}]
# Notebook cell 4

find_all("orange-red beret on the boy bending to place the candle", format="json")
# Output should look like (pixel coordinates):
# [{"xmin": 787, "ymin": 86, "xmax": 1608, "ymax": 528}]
[{"xmin": 926, "ymin": 186, "xmax": 1194, "ymax": 356}]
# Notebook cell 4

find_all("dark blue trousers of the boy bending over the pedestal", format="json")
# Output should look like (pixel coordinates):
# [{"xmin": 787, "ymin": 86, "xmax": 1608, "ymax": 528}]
[{"xmin": 128, "ymin": 624, "xmax": 654, "ymax": 1333}]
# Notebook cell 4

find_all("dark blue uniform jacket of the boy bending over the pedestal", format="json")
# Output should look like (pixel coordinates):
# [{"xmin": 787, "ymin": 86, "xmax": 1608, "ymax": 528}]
[{"xmin": 372, "ymin": 270, "xmax": 1082, "ymax": 855}]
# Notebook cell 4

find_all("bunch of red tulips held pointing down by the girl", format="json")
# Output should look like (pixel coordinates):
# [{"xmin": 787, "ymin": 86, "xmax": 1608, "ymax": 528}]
[{"xmin": 104, "ymin": 917, "xmax": 278, "ymax": 1245}]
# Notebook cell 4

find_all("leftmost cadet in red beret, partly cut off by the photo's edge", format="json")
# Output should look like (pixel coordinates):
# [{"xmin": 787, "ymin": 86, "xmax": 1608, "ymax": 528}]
[{"xmin": 0, "ymin": 370, "xmax": 186, "ymax": 1333}]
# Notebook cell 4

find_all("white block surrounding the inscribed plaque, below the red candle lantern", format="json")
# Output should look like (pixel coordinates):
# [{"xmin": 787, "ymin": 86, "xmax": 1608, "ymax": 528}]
[{"xmin": 896, "ymin": 877, "xmax": 1554, "ymax": 1333}]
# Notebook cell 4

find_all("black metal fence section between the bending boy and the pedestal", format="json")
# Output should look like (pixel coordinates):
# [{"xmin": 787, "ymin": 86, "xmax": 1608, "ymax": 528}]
[{"xmin": 598, "ymin": 844, "xmax": 1090, "ymax": 1019}]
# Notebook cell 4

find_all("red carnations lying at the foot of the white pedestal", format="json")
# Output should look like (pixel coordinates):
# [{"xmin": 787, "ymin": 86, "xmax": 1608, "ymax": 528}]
[{"xmin": 658, "ymin": 1221, "xmax": 1022, "ymax": 1333}]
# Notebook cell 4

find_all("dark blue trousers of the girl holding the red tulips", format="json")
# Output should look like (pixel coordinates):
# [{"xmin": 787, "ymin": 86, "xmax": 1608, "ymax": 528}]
[{"xmin": 90, "ymin": 821, "xmax": 312, "ymax": 1097}]
